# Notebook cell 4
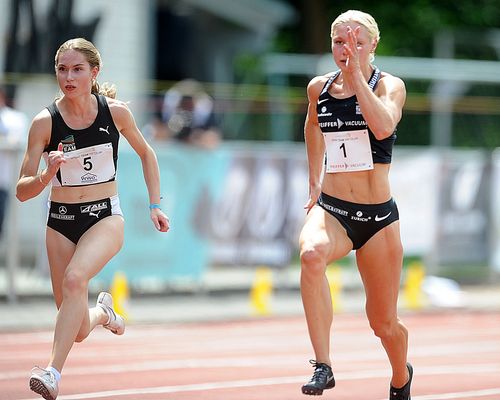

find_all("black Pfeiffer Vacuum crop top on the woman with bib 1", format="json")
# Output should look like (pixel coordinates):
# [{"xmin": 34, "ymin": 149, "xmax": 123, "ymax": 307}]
[{"xmin": 316, "ymin": 68, "xmax": 396, "ymax": 164}]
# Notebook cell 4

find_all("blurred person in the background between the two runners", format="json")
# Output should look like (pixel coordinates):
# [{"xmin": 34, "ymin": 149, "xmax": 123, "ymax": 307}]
[{"xmin": 149, "ymin": 79, "xmax": 221, "ymax": 149}]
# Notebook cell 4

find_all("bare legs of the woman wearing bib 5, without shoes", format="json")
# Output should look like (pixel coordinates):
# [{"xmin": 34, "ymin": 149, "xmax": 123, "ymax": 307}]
[{"xmin": 47, "ymin": 216, "xmax": 123, "ymax": 371}]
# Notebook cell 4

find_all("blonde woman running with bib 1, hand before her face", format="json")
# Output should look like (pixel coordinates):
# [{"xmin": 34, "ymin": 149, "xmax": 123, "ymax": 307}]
[{"xmin": 300, "ymin": 10, "xmax": 413, "ymax": 400}]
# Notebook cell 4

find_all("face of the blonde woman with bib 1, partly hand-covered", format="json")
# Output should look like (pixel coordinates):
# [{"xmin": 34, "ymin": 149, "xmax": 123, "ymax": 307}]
[{"xmin": 332, "ymin": 22, "xmax": 376, "ymax": 69}]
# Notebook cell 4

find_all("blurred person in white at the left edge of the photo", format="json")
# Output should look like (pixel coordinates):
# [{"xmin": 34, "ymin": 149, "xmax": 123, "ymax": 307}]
[{"xmin": 0, "ymin": 86, "xmax": 28, "ymax": 237}]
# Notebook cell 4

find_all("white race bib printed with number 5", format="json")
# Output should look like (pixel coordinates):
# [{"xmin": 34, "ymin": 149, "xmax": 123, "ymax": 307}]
[{"xmin": 60, "ymin": 143, "xmax": 116, "ymax": 186}]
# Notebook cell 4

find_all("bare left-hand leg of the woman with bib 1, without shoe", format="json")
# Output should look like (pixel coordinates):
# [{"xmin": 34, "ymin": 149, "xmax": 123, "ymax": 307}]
[{"xmin": 300, "ymin": 206, "xmax": 352, "ymax": 365}]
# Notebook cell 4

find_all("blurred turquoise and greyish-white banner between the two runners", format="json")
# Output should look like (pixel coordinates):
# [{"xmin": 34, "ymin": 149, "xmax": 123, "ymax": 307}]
[{"xmin": 97, "ymin": 145, "xmax": 308, "ymax": 286}]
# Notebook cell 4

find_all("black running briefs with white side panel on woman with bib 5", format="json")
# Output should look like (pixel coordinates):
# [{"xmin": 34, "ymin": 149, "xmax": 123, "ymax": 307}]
[{"xmin": 47, "ymin": 196, "xmax": 123, "ymax": 244}]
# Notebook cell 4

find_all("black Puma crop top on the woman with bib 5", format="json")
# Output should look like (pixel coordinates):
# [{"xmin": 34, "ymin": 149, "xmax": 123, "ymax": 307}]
[{"xmin": 44, "ymin": 94, "xmax": 120, "ymax": 185}]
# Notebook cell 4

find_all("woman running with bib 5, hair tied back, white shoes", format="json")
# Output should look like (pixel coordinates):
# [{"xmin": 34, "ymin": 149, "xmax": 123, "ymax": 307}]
[{"xmin": 16, "ymin": 38, "xmax": 169, "ymax": 400}]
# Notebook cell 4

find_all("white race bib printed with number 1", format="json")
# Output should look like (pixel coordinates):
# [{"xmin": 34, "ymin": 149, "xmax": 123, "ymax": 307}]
[{"xmin": 323, "ymin": 129, "xmax": 373, "ymax": 173}]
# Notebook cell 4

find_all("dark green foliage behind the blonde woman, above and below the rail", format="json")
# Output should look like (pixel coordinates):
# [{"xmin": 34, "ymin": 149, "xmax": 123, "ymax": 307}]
[{"xmin": 254, "ymin": 0, "xmax": 500, "ymax": 148}]
